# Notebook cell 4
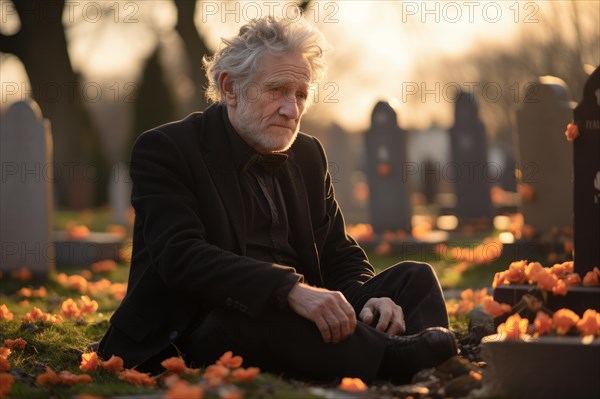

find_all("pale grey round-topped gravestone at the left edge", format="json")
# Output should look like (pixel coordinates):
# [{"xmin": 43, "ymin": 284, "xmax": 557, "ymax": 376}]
[{"xmin": 0, "ymin": 100, "xmax": 58, "ymax": 277}]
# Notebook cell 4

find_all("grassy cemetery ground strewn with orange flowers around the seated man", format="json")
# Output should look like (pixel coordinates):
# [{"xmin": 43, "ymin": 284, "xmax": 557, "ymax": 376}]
[{"xmin": 0, "ymin": 210, "xmax": 596, "ymax": 399}]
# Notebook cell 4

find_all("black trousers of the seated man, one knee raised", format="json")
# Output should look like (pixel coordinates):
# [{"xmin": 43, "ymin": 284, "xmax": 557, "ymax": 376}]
[{"xmin": 181, "ymin": 262, "xmax": 448, "ymax": 382}]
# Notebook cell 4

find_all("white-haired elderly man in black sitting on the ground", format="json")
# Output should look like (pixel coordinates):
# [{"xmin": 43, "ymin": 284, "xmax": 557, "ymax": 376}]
[{"xmin": 99, "ymin": 17, "xmax": 457, "ymax": 382}]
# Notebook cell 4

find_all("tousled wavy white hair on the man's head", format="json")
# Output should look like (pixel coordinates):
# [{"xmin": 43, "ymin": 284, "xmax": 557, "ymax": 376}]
[{"xmin": 202, "ymin": 16, "xmax": 327, "ymax": 103}]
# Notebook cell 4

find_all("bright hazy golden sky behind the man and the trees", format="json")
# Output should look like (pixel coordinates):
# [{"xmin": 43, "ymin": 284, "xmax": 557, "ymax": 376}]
[{"xmin": 0, "ymin": 0, "xmax": 600, "ymax": 132}]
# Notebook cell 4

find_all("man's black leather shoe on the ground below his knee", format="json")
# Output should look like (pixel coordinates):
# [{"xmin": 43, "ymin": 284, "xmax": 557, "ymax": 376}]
[{"xmin": 378, "ymin": 327, "xmax": 458, "ymax": 383}]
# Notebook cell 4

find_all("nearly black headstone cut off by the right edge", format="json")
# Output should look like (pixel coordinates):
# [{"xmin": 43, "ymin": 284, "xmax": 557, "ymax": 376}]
[{"xmin": 573, "ymin": 67, "xmax": 600, "ymax": 276}]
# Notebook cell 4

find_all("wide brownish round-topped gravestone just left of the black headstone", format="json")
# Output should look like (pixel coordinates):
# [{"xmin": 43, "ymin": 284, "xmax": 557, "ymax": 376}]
[{"xmin": 517, "ymin": 77, "xmax": 573, "ymax": 237}]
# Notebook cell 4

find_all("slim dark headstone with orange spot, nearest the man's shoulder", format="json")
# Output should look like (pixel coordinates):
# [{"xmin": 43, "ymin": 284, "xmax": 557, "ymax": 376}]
[{"xmin": 365, "ymin": 101, "xmax": 411, "ymax": 233}]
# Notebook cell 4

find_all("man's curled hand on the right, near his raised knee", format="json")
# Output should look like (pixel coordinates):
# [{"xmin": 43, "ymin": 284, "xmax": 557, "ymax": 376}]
[{"xmin": 359, "ymin": 298, "xmax": 406, "ymax": 335}]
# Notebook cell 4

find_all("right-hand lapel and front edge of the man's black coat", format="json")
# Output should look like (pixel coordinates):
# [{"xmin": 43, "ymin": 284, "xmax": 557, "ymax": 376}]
[{"xmin": 278, "ymin": 161, "xmax": 323, "ymax": 286}]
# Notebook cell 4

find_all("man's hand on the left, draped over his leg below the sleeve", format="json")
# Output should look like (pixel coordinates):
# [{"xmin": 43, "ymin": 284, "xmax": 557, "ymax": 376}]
[{"xmin": 288, "ymin": 283, "xmax": 356, "ymax": 344}]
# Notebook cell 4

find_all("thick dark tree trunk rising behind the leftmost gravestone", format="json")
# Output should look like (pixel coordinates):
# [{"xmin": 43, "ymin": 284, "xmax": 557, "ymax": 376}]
[{"xmin": 0, "ymin": 0, "xmax": 106, "ymax": 209}]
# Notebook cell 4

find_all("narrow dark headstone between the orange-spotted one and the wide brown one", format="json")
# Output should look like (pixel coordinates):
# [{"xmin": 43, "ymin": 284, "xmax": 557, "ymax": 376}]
[{"xmin": 445, "ymin": 92, "xmax": 493, "ymax": 225}]
